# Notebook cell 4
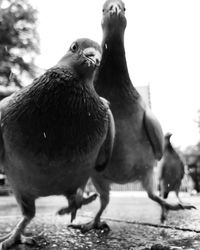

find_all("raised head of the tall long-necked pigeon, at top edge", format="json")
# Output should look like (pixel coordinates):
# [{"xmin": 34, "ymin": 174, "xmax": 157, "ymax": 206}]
[{"xmin": 101, "ymin": 0, "xmax": 127, "ymax": 33}]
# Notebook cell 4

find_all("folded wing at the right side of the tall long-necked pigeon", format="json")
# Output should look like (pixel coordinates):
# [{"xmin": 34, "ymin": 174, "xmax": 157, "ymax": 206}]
[{"xmin": 144, "ymin": 108, "xmax": 164, "ymax": 160}]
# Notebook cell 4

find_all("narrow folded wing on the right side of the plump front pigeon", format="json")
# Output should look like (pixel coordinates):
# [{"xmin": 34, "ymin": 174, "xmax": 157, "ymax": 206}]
[{"xmin": 95, "ymin": 97, "xmax": 115, "ymax": 172}]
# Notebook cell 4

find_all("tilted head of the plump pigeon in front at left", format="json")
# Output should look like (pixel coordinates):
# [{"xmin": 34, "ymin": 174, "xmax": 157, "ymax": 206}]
[{"xmin": 57, "ymin": 38, "xmax": 102, "ymax": 78}]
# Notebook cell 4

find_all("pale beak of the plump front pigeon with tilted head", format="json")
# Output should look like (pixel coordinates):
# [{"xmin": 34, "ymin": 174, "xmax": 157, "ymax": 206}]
[{"xmin": 83, "ymin": 48, "xmax": 101, "ymax": 67}]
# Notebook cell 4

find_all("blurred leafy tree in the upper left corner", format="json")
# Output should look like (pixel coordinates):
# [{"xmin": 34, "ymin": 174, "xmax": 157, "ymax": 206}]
[{"xmin": 0, "ymin": 0, "xmax": 39, "ymax": 87}]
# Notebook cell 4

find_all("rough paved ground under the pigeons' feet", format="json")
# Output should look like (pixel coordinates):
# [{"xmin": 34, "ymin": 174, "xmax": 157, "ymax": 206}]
[{"xmin": 0, "ymin": 192, "xmax": 200, "ymax": 250}]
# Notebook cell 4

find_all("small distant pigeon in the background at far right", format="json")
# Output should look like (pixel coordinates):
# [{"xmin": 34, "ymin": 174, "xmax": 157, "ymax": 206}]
[{"xmin": 158, "ymin": 133, "xmax": 185, "ymax": 203}]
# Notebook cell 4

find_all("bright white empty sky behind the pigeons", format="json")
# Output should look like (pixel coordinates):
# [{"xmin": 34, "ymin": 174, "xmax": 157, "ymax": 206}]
[{"xmin": 31, "ymin": 0, "xmax": 200, "ymax": 148}]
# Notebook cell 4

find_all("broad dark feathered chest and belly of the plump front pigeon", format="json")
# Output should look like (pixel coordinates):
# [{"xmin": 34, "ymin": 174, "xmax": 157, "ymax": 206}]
[{"xmin": 2, "ymin": 70, "xmax": 108, "ymax": 196}]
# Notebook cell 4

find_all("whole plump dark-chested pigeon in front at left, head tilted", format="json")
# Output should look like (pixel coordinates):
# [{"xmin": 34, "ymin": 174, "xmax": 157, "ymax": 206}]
[{"xmin": 0, "ymin": 39, "xmax": 114, "ymax": 250}]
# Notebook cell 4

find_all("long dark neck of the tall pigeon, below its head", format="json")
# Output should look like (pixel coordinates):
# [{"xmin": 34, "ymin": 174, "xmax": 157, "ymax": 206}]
[{"xmin": 94, "ymin": 29, "xmax": 138, "ymax": 106}]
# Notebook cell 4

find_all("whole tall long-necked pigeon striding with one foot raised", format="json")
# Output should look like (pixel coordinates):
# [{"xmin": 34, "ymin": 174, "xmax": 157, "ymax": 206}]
[{"xmin": 70, "ymin": 0, "xmax": 195, "ymax": 232}]
